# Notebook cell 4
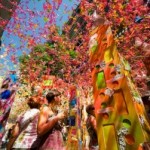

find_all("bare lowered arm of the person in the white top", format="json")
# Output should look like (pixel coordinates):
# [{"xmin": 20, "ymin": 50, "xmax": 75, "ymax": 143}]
[{"xmin": 7, "ymin": 123, "xmax": 20, "ymax": 150}]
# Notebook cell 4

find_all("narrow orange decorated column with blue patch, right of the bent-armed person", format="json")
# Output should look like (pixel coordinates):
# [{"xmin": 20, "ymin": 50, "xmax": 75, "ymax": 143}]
[{"xmin": 67, "ymin": 86, "xmax": 82, "ymax": 150}]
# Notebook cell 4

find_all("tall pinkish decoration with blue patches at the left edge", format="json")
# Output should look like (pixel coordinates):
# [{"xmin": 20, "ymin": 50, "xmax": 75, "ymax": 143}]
[{"xmin": 0, "ymin": 71, "xmax": 18, "ymax": 144}]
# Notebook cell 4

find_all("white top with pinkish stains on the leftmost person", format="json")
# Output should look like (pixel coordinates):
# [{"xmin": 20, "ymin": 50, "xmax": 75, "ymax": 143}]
[{"xmin": 13, "ymin": 109, "xmax": 40, "ymax": 149}]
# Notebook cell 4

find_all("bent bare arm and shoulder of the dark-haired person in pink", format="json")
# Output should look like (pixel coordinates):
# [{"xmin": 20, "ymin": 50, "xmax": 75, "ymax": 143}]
[{"xmin": 37, "ymin": 107, "xmax": 64, "ymax": 136}]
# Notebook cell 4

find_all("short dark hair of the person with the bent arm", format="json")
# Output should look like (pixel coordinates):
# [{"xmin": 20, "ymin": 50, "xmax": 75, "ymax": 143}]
[{"xmin": 46, "ymin": 90, "xmax": 61, "ymax": 103}]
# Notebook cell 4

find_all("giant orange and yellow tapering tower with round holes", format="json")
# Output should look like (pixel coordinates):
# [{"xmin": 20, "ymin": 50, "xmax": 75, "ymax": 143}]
[{"xmin": 89, "ymin": 11, "xmax": 150, "ymax": 150}]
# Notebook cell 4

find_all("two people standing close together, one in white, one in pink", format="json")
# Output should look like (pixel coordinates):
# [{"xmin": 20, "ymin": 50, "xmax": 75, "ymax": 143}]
[{"xmin": 6, "ymin": 87, "xmax": 67, "ymax": 150}]
